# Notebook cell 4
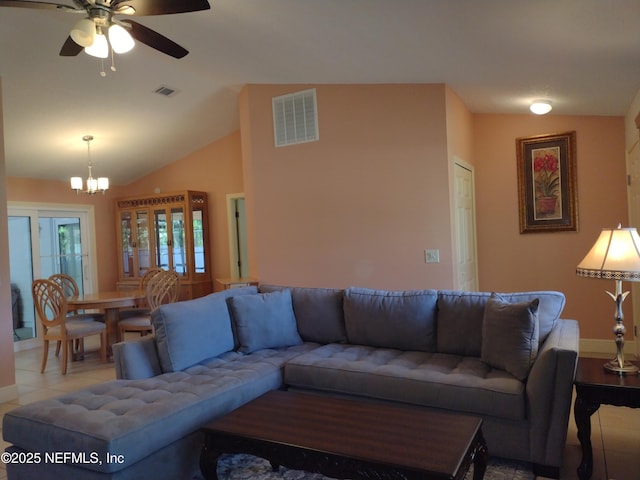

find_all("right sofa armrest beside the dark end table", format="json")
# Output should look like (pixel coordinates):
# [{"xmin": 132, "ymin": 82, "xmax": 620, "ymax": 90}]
[{"xmin": 526, "ymin": 319, "xmax": 580, "ymax": 467}]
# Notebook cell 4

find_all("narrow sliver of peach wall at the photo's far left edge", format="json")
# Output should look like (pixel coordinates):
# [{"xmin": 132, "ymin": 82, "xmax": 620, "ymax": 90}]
[{"xmin": 0, "ymin": 78, "xmax": 18, "ymax": 402}]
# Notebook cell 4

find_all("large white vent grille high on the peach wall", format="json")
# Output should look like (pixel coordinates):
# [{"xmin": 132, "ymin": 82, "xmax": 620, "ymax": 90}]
[{"xmin": 272, "ymin": 88, "xmax": 318, "ymax": 147}]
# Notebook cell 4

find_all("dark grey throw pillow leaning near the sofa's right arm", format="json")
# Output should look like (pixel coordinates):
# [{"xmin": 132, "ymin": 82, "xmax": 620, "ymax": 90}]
[{"xmin": 481, "ymin": 293, "xmax": 540, "ymax": 381}]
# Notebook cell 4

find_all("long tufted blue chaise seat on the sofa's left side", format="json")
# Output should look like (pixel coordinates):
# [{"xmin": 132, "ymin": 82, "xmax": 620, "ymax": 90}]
[{"xmin": 2, "ymin": 344, "xmax": 317, "ymax": 472}]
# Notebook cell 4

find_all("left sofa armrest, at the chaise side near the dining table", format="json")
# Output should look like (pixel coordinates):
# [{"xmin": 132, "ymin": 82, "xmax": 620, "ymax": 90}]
[{"xmin": 113, "ymin": 337, "xmax": 162, "ymax": 380}]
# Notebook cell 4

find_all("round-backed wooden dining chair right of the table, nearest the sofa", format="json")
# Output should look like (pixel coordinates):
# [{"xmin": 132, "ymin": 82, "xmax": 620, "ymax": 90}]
[{"xmin": 117, "ymin": 270, "xmax": 180, "ymax": 342}]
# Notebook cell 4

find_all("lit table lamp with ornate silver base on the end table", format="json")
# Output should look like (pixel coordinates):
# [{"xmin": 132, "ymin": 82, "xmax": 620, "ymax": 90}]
[{"xmin": 576, "ymin": 225, "xmax": 640, "ymax": 375}]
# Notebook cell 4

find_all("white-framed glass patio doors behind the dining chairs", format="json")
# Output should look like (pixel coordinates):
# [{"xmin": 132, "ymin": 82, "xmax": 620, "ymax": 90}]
[{"xmin": 8, "ymin": 202, "xmax": 96, "ymax": 351}]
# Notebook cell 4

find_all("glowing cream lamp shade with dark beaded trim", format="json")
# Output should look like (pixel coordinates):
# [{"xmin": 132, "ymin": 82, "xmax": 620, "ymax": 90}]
[{"xmin": 576, "ymin": 227, "xmax": 640, "ymax": 282}]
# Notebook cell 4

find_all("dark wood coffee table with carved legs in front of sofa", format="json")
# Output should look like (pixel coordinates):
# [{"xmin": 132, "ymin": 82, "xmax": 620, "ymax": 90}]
[{"xmin": 200, "ymin": 391, "xmax": 488, "ymax": 480}]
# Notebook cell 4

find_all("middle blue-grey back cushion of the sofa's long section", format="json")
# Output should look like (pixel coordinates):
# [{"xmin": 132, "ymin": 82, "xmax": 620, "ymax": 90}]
[{"xmin": 344, "ymin": 287, "xmax": 438, "ymax": 352}]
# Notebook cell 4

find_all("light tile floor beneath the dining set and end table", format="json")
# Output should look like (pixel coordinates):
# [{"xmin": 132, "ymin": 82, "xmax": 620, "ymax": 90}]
[{"xmin": 0, "ymin": 345, "xmax": 640, "ymax": 480}]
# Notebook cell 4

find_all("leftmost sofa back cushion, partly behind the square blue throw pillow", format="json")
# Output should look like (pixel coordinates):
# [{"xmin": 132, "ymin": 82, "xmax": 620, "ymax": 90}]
[{"xmin": 260, "ymin": 285, "xmax": 347, "ymax": 343}]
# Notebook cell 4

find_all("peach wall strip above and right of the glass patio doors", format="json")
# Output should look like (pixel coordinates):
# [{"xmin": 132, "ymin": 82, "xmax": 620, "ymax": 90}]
[{"xmin": 6, "ymin": 177, "xmax": 122, "ymax": 290}]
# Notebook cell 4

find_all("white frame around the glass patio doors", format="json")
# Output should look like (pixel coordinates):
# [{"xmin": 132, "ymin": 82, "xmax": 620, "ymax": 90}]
[{"xmin": 7, "ymin": 201, "xmax": 98, "ymax": 352}]
